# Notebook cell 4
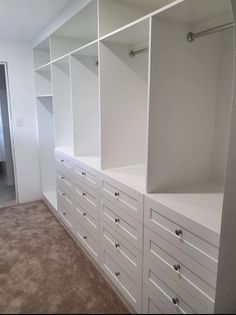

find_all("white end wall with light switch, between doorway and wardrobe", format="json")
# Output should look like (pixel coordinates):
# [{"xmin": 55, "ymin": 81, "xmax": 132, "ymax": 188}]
[{"xmin": 0, "ymin": 41, "xmax": 41, "ymax": 203}]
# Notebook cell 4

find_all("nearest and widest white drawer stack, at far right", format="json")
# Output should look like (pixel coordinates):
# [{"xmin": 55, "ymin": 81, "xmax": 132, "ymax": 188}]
[{"xmin": 143, "ymin": 197, "xmax": 219, "ymax": 314}]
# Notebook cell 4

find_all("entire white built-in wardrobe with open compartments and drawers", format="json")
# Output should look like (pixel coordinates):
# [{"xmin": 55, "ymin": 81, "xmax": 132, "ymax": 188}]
[{"xmin": 34, "ymin": 0, "xmax": 236, "ymax": 314}]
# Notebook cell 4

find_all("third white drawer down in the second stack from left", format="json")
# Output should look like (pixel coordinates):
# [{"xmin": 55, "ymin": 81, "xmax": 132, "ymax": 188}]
[{"xmin": 73, "ymin": 202, "xmax": 99, "ymax": 237}]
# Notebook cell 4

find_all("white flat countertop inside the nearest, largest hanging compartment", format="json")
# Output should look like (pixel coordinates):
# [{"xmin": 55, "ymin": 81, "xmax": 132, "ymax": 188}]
[{"xmin": 148, "ymin": 181, "xmax": 224, "ymax": 234}]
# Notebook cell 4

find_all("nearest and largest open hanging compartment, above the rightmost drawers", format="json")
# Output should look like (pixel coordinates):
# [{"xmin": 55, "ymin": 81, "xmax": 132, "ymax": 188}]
[{"xmin": 147, "ymin": 0, "xmax": 234, "ymax": 233}]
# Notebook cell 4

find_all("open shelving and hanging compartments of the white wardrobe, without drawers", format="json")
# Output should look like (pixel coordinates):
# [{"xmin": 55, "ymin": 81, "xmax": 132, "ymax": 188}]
[{"xmin": 34, "ymin": 0, "xmax": 235, "ymax": 312}]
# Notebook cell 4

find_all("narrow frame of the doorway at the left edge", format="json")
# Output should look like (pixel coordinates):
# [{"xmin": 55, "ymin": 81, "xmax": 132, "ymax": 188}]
[{"xmin": 0, "ymin": 60, "xmax": 19, "ymax": 208}]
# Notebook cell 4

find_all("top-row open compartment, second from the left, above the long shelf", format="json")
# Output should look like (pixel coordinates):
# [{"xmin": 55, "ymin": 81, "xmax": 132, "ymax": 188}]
[{"xmin": 50, "ymin": 1, "xmax": 98, "ymax": 60}]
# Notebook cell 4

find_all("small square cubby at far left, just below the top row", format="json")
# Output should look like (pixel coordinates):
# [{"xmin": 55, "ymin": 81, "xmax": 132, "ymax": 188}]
[{"xmin": 35, "ymin": 65, "xmax": 52, "ymax": 97}]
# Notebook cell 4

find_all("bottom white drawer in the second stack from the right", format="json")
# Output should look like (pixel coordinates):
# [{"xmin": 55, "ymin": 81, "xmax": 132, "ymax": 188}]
[{"xmin": 102, "ymin": 245, "xmax": 142, "ymax": 313}]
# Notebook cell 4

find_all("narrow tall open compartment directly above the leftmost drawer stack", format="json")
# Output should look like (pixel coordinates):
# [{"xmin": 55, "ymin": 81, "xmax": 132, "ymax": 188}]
[{"xmin": 52, "ymin": 56, "xmax": 74, "ymax": 146}]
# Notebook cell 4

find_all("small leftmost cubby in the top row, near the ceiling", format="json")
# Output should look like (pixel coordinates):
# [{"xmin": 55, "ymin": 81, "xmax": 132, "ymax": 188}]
[{"xmin": 33, "ymin": 38, "xmax": 51, "ymax": 69}]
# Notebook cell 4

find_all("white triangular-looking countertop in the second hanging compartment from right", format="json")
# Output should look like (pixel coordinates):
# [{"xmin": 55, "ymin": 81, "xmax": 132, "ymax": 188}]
[{"xmin": 103, "ymin": 164, "xmax": 146, "ymax": 194}]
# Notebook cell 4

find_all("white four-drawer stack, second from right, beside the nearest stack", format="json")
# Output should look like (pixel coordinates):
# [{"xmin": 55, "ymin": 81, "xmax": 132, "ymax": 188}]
[{"xmin": 100, "ymin": 174, "xmax": 143, "ymax": 313}]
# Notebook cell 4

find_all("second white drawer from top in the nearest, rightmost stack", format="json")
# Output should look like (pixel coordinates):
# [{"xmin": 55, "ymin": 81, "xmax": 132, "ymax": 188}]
[{"xmin": 144, "ymin": 228, "xmax": 215, "ymax": 312}]
